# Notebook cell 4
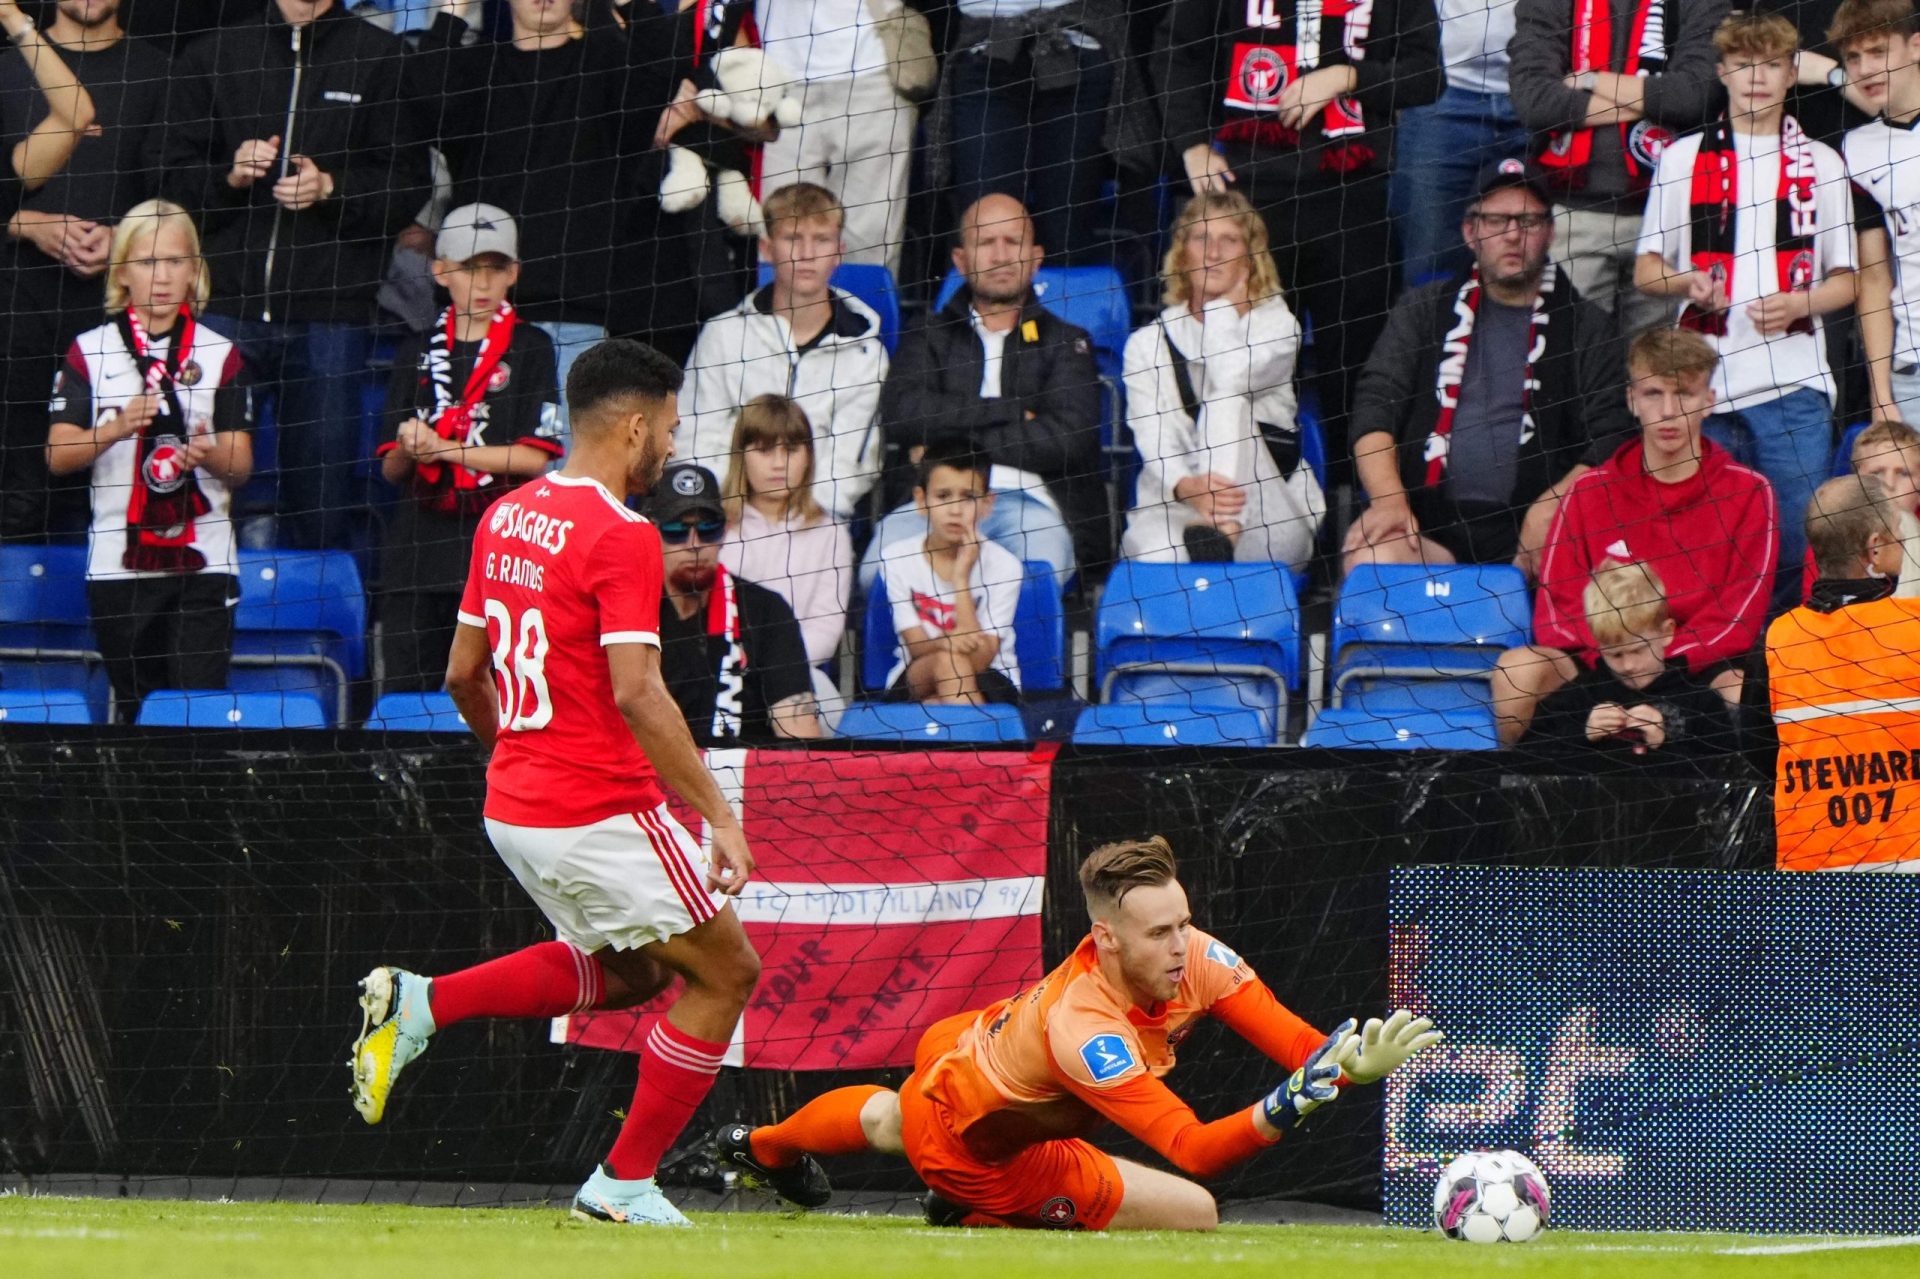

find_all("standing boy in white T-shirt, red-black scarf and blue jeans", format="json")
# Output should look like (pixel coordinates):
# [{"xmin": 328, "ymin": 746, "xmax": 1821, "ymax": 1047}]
[{"xmin": 1634, "ymin": 13, "xmax": 1853, "ymax": 613}]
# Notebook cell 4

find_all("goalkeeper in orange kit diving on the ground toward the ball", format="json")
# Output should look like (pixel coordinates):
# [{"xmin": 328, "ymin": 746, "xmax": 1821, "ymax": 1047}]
[{"xmin": 716, "ymin": 835, "xmax": 1440, "ymax": 1231}]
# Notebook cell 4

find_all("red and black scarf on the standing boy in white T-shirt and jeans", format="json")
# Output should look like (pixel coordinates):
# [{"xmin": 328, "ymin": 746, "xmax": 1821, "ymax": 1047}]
[{"xmin": 1680, "ymin": 115, "xmax": 1820, "ymax": 338}]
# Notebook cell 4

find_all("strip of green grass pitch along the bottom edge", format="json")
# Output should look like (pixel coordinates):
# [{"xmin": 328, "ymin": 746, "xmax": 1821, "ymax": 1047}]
[{"xmin": 0, "ymin": 1196, "xmax": 1920, "ymax": 1279}]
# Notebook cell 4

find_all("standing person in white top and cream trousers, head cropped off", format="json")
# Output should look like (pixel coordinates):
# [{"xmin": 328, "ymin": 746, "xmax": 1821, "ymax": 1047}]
[{"xmin": 755, "ymin": 0, "xmax": 916, "ymax": 274}]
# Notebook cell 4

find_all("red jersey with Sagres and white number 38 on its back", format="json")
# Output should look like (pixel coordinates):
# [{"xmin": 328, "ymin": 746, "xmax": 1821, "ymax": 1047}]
[{"xmin": 461, "ymin": 474, "xmax": 662, "ymax": 826}]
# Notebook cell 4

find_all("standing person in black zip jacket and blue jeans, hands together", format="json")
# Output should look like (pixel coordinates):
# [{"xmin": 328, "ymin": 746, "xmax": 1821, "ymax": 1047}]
[{"xmin": 163, "ymin": 0, "xmax": 428, "ymax": 547}]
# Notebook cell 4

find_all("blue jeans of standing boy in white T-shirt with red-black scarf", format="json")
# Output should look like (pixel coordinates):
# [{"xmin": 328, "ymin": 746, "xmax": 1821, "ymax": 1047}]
[{"xmin": 1703, "ymin": 386, "xmax": 1834, "ymax": 616}]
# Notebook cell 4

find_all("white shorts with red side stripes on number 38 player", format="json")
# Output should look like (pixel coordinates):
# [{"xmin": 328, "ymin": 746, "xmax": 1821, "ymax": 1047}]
[{"xmin": 486, "ymin": 805, "xmax": 726, "ymax": 953}]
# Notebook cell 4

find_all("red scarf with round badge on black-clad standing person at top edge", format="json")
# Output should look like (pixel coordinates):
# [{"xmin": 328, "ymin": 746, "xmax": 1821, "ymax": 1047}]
[{"xmin": 1219, "ymin": 0, "xmax": 1379, "ymax": 173}]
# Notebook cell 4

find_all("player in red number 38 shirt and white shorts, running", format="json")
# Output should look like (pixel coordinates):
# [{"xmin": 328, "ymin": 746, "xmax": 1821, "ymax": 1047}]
[{"xmin": 351, "ymin": 340, "xmax": 760, "ymax": 1225}]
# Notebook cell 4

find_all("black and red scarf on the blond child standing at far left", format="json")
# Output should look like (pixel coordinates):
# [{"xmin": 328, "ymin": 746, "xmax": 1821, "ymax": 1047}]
[{"xmin": 113, "ymin": 307, "xmax": 213, "ymax": 572}]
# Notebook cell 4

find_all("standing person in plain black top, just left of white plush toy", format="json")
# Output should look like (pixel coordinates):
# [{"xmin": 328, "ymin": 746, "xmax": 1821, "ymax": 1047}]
[{"xmin": 409, "ymin": 0, "xmax": 699, "ymax": 405}]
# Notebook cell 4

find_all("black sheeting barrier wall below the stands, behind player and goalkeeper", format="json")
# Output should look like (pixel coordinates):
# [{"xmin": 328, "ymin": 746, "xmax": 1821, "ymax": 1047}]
[{"xmin": 0, "ymin": 728, "xmax": 1772, "ymax": 1206}]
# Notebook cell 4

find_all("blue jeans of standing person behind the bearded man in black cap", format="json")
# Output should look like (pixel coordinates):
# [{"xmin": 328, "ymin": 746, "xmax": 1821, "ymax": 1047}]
[{"xmin": 1388, "ymin": 86, "xmax": 1526, "ymax": 288}]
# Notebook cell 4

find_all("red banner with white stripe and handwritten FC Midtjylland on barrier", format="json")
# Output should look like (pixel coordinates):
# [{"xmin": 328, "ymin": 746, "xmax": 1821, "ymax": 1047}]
[{"xmin": 555, "ymin": 747, "xmax": 1054, "ymax": 1070}]
